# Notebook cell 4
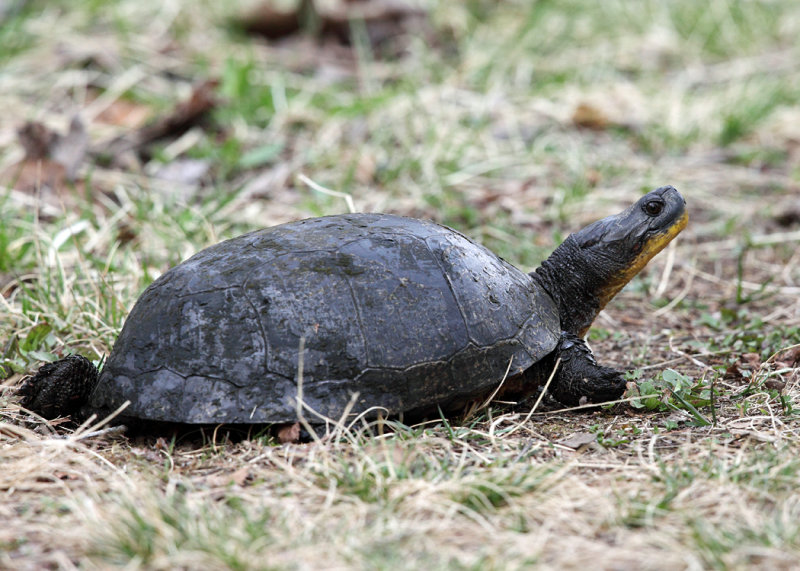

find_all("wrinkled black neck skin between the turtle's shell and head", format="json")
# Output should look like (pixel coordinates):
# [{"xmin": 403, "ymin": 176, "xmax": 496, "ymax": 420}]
[{"xmin": 530, "ymin": 235, "xmax": 616, "ymax": 337}]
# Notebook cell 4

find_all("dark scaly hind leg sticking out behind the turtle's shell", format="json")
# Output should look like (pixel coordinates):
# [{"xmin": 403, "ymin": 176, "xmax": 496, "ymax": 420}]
[{"xmin": 17, "ymin": 355, "xmax": 98, "ymax": 419}]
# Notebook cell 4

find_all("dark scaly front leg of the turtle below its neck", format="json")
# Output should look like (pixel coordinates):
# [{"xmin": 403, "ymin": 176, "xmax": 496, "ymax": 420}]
[{"xmin": 549, "ymin": 332, "xmax": 625, "ymax": 406}]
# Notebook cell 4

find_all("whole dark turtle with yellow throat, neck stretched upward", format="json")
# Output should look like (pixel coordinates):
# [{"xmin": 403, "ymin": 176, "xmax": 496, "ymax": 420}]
[{"xmin": 18, "ymin": 186, "xmax": 688, "ymax": 432}]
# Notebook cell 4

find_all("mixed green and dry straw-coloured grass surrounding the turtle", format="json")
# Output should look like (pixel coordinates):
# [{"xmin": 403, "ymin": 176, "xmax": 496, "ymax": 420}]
[{"xmin": 0, "ymin": 0, "xmax": 800, "ymax": 569}]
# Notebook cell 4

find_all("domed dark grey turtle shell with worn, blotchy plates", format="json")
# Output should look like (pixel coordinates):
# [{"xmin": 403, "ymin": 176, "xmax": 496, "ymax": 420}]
[{"xmin": 90, "ymin": 214, "xmax": 560, "ymax": 423}]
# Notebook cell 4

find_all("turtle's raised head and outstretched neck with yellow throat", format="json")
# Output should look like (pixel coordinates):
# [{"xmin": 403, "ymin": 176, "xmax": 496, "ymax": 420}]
[{"xmin": 534, "ymin": 186, "xmax": 689, "ymax": 336}]
